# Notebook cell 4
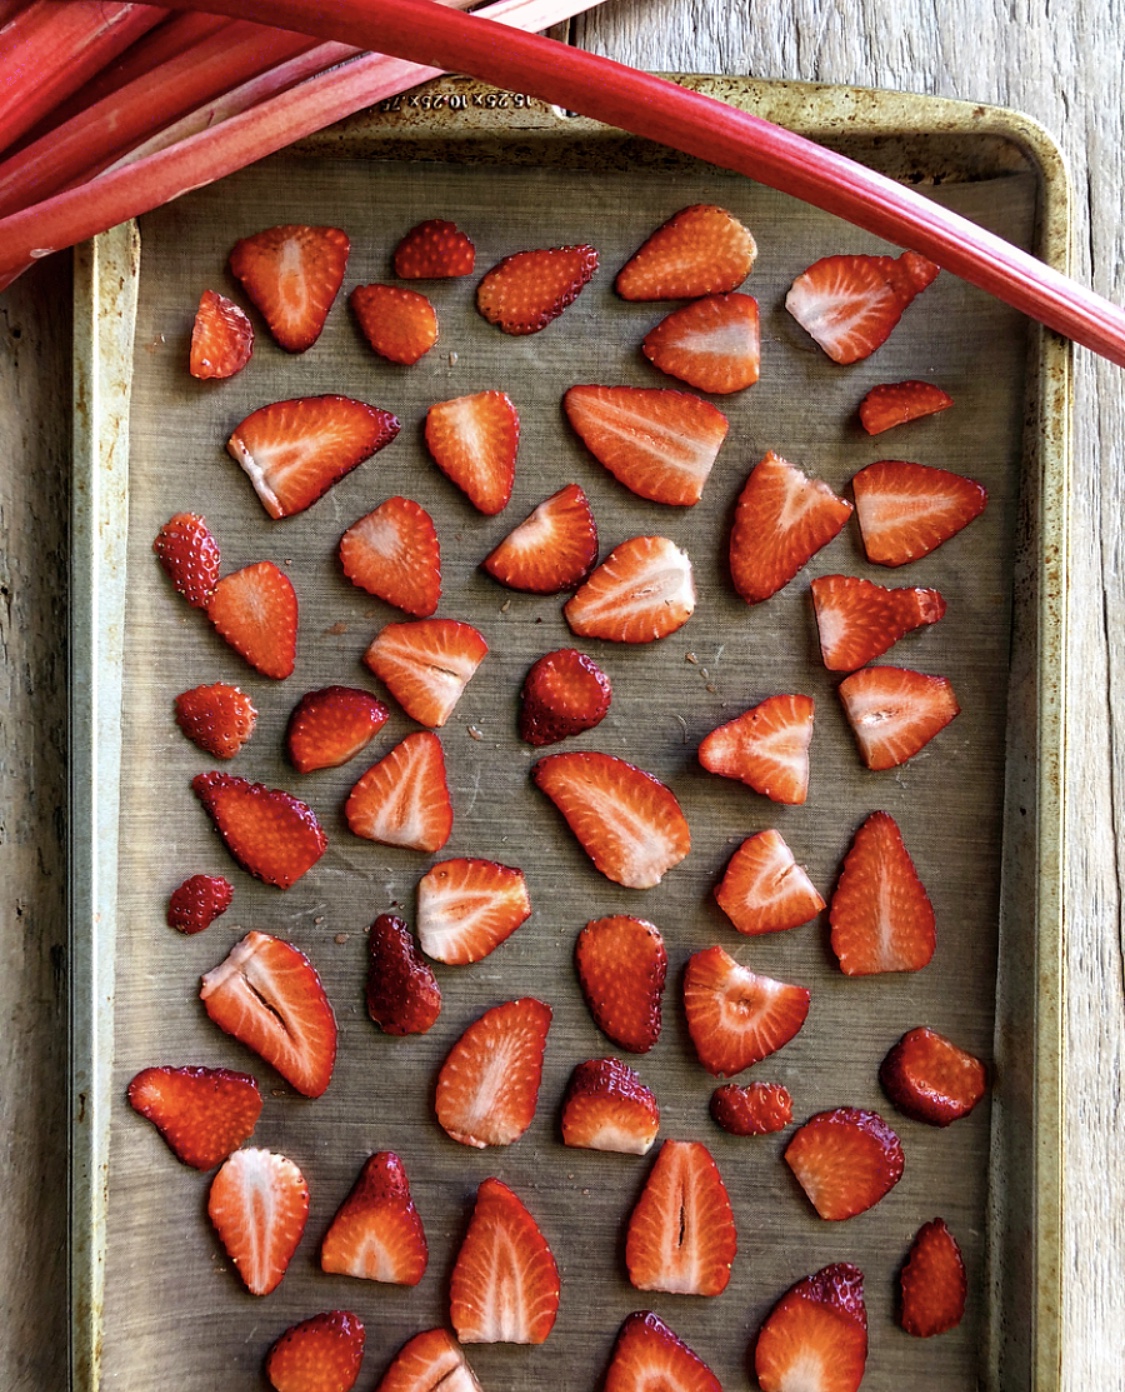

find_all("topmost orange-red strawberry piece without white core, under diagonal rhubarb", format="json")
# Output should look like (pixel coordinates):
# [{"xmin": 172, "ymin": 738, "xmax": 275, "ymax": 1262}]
[{"xmin": 614, "ymin": 203, "xmax": 757, "ymax": 299}]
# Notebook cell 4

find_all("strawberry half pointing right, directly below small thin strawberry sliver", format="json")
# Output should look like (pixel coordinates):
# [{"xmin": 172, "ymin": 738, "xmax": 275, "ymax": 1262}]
[{"xmin": 852, "ymin": 459, "xmax": 989, "ymax": 565}]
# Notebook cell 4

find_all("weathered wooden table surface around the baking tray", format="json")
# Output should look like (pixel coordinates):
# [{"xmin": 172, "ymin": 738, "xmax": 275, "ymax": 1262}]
[{"xmin": 0, "ymin": 0, "xmax": 1125, "ymax": 1392}]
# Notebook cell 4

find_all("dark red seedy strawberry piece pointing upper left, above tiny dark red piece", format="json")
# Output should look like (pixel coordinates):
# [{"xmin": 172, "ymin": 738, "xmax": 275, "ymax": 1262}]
[{"xmin": 192, "ymin": 773, "xmax": 329, "ymax": 889}]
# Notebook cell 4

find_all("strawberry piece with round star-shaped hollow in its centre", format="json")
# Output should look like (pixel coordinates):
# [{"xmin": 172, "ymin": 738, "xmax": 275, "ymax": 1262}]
[{"xmin": 684, "ymin": 947, "xmax": 809, "ymax": 1077}]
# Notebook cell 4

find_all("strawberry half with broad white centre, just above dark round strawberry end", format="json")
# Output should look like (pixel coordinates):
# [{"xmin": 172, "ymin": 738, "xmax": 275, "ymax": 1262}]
[{"xmin": 563, "ymin": 536, "xmax": 695, "ymax": 643}]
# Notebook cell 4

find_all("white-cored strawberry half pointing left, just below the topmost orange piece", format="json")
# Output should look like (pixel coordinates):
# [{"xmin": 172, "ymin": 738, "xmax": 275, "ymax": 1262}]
[{"xmin": 640, "ymin": 295, "xmax": 762, "ymax": 395}]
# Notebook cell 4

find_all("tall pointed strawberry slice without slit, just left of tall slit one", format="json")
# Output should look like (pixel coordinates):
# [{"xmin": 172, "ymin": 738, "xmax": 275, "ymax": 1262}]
[{"xmin": 450, "ymin": 1179, "xmax": 558, "ymax": 1343}]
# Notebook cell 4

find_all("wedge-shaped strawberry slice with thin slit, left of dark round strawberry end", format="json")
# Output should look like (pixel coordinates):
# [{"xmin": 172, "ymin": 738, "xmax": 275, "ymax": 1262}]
[{"xmin": 363, "ymin": 618, "xmax": 489, "ymax": 728}]
